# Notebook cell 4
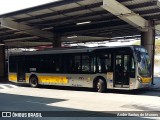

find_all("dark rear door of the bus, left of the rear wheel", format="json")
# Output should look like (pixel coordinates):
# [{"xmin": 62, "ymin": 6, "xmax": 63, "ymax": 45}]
[{"xmin": 17, "ymin": 57, "xmax": 25, "ymax": 82}]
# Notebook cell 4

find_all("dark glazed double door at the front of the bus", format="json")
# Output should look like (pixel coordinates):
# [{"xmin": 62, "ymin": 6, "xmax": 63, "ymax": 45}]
[{"xmin": 114, "ymin": 54, "xmax": 130, "ymax": 88}]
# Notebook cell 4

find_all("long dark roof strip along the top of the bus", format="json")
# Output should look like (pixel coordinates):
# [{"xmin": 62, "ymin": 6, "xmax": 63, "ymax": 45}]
[{"xmin": 10, "ymin": 45, "xmax": 141, "ymax": 56}]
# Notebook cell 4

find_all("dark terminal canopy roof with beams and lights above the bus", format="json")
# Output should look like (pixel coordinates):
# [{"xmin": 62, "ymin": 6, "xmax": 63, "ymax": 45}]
[{"xmin": 0, "ymin": 0, "xmax": 160, "ymax": 47}]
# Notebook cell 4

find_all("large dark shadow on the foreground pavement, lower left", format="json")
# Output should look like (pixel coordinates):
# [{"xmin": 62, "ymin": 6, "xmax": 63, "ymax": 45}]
[{"xmin": 0, "ymin": 93, "xmax": 154, "ymax": 120}]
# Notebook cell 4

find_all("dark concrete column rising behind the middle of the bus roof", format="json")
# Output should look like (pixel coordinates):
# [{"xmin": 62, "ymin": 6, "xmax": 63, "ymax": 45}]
[{"xmin": 53, "ymin": 33, "xmax": 61, "ymax": 47}]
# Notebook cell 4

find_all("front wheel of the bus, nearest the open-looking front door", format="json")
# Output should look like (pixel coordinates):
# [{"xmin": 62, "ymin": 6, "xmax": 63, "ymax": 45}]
[{"xmin": 96, "ymin": 79, "xmax": 106, "ymax": 93}]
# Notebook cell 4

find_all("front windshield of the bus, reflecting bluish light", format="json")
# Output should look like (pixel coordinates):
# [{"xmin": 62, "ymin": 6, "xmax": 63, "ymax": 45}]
[{"xmin": 135, "ymin": 47, "xmax": 151, "ymax": 77}]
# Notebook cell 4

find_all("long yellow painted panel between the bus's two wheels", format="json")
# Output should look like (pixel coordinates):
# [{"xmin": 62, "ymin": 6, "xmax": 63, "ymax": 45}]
[{"xmin": 38, "ymin": 76, "xmax": 68, "ymax": 84}]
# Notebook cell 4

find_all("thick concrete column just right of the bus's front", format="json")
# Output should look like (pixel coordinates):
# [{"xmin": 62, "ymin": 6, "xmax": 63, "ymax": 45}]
[{"xmin": 141, "ymin": 21, "xmax": 155, "ymax": 84}]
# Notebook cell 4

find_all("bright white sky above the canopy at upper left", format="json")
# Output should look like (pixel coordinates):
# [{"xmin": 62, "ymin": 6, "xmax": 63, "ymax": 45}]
[{"xmin": 0, "ymin": 0, "xmax": 58, "ymax": 15}]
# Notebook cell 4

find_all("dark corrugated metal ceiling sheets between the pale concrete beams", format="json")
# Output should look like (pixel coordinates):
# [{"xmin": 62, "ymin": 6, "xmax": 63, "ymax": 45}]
[{"xmin": 0, "ymin": 0, "xmax": 160, "ymax": 47}]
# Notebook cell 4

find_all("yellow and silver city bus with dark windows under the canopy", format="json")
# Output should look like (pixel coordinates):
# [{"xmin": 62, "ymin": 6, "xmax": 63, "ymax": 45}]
[{"xmin": 8, "ymin": 46, "xmax": 151, "ymax": 92}]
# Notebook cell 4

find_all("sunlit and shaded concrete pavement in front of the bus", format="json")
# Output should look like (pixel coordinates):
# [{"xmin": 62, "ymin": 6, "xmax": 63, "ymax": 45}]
[{"xmin": 0, "ymin": 78, "xmax": 160, "ymax": 120}]
